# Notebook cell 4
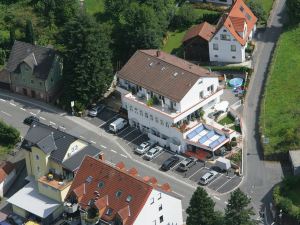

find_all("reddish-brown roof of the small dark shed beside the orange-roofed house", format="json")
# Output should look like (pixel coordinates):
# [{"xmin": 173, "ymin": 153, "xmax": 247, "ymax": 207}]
[{"xmin": 182, "ymin": 22, "xmax": 216, "ymax": 42}]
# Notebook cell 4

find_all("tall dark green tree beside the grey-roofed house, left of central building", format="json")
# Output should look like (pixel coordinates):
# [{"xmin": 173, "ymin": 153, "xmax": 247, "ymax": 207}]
[{"xmin": 60, "ymin": 14, "xmax": 113, "ymax": 106}]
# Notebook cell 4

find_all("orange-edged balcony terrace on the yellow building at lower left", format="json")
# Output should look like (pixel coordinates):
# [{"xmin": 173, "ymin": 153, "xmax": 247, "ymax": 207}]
[{"xmin": 39, "ymin": 173, "xmax": 72, "ymax": 191}]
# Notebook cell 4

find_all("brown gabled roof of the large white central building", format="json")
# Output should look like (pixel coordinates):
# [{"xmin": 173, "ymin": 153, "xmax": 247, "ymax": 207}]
[{"xmin": 117, "ymin": 49, "xmax": 218, "ymax": 102}]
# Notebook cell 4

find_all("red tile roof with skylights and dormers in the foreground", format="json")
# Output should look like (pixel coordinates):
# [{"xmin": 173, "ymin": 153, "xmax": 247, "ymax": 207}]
[{"xmin": 67, "ymin": 156, "xmax": 153, "ymax": 225}]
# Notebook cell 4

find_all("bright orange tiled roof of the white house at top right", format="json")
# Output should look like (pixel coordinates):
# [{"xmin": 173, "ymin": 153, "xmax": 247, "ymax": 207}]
[{"xmin": 216, "ymin": 0, "xmax": 257, "ymax": 45}]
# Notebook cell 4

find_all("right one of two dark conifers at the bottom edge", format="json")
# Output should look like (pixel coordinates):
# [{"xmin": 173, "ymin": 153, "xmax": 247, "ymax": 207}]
[{"xmin": 225, "ymin": 189, "xmax": 257, "ymax": 225}]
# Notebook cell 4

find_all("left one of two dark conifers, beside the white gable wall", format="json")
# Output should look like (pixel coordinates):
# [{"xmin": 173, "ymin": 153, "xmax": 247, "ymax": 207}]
[{"xmin": 186, "ymin": 187, "xmax": 220, "ymax": 225}]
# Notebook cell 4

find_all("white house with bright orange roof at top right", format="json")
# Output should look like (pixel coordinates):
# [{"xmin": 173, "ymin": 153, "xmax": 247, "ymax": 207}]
[{"xmin": 209, "ymin": 0, "xmax": 257, "ymax": 63}]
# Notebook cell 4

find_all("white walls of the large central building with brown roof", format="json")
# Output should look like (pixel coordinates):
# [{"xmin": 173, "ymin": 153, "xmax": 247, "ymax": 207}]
[{"xmin": 117, "ymin": 77, "xmax": 223, "ymax": 152}]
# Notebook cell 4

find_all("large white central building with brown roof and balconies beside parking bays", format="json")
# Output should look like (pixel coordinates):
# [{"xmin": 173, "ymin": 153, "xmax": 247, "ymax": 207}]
[{"xmin": 117, "ymin": 50, "xmax": 229, "ymax": 152}]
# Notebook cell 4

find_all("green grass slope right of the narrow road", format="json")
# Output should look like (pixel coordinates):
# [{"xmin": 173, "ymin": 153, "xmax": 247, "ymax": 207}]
[{"xmin": 260, "ymin": 27, "xmax": 300, "ymax": 156}]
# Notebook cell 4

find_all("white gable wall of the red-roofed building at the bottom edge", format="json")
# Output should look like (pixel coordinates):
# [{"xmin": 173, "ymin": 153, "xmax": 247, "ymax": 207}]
[{"xmin": 133, "ymin": 189, "xmax": 183, "ymax": 225}]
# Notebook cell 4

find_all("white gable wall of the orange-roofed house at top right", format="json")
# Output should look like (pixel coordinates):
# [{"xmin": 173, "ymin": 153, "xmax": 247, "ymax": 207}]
[{"xmin": 209, "ymin": 26, "xmax": 246, "ymax": 63}]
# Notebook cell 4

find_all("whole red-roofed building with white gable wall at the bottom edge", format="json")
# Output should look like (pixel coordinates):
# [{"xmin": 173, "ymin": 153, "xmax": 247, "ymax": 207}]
[{"xmin": 64, "ymin": 156, "xmax": 183, "ymax": 225}]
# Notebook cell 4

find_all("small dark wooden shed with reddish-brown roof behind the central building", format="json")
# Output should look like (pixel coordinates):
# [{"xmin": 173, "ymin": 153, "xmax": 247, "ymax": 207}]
[{"xmin": 182, "ymin": 22, "xmax": 216, "ymax": 62}]
